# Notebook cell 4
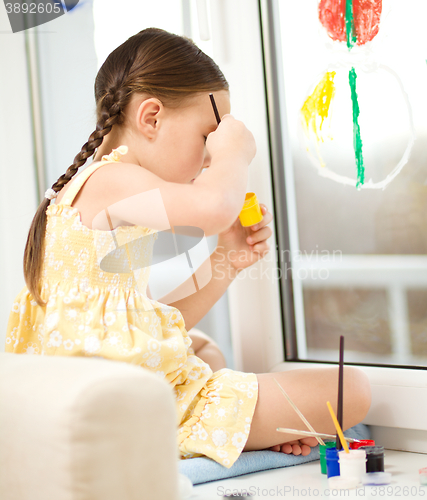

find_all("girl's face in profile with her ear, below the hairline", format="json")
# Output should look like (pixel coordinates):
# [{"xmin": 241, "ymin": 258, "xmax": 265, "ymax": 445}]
[{"xmin": 130, "ymin": 90, "xmax": 230, "ymax": 184}]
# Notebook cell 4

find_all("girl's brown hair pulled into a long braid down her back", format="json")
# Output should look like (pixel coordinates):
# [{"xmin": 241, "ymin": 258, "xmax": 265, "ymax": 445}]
[{"xmin": 23, "ymin": 28, "xmax": 228, "ymax": 307}]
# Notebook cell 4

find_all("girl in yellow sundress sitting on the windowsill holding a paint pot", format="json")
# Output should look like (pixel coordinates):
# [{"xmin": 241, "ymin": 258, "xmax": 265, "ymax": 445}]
[{"xmin": 6, "ymin": 28, "xmax": 370, "ymax": 467}]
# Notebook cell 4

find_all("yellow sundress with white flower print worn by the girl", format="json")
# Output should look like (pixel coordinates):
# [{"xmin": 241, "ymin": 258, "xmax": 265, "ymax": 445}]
[{"xmin": 6, "ymin": 146, "xmax": 258, "ymax": 468}]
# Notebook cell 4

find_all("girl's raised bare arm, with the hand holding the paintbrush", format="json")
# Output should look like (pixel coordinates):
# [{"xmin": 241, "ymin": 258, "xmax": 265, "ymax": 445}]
[{"xmin": 92, "ymin": 117, "xmax": 255, "ymax": 236}]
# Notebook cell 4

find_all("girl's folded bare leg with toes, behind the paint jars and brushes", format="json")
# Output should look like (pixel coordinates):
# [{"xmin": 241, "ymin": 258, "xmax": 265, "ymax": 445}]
[{"xmin": 244, "ymin": 366, "xmax": 371, "ymax": 455}]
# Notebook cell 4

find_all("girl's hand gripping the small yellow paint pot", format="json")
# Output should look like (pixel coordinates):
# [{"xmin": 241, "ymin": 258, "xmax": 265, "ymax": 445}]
[{"xmin": 216, "ymin": 203, "xmax": 273, "ymax": 271}]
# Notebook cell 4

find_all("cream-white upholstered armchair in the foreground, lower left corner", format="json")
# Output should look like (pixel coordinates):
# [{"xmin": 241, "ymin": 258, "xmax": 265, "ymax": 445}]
[{"xmin": 0, "ymin": 353, "xmax": 179, "ymax": 500}]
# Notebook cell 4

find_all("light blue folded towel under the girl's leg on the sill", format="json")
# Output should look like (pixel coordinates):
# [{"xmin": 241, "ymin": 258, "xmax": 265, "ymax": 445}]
[{"xmin": 179, "ymin": 424, "xmax": 370, "ymax": 484}]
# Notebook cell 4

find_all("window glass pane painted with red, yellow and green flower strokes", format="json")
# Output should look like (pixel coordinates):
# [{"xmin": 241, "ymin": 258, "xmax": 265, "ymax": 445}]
[{"xmin": 278, "ymin": 0, "xmax": 427, "ymax": 366}]
